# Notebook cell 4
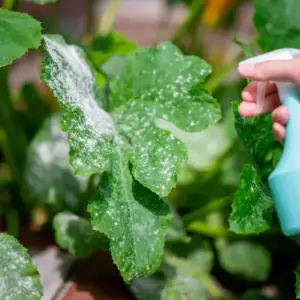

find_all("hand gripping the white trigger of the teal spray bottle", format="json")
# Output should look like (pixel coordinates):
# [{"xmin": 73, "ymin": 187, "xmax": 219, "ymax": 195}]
[{"xmin": 238, "ymin": 58, "xmax": 300, "ymax": 142}]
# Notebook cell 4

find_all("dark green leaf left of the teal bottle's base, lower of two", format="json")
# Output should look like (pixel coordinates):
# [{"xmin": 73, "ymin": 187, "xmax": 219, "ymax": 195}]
[{"xmin": 229, "ymin": 165, "xmax": 273, "ymax": 234}]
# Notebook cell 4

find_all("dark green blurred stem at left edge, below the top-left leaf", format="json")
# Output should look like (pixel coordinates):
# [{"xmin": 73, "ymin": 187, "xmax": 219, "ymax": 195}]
[{"xmin": 0, "ymin": 67, "xmax": 28, "ymax": 187}]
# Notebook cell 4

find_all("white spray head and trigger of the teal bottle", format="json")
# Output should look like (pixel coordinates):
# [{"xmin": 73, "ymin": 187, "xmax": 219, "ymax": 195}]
[{"xmin": 239, "ymin": 48, "xmax": 300, "ymax": 114}]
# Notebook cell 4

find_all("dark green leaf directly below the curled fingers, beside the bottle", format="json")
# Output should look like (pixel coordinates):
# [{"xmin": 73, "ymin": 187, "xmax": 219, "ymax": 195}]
[{"xmin": 233, "ymin": 101, "xmax": 282, "ymax": 179}]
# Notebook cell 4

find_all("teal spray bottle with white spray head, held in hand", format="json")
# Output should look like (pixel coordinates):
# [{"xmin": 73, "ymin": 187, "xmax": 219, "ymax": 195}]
[{"xmin": 240, "ymin": 49, "xmax": 300, "ymax": 241}]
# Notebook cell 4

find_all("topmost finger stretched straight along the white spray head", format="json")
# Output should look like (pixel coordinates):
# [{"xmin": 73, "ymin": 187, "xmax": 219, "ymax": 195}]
[{"xmin": 238, "ymin": 58, "xmax": 300, "ymax": 84}]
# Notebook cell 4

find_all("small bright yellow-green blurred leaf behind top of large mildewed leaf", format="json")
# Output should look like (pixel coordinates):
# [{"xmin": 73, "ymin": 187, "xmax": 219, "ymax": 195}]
[{"xmin": 87, "ymin": 32, "xmax": 137, "ymax": 68}]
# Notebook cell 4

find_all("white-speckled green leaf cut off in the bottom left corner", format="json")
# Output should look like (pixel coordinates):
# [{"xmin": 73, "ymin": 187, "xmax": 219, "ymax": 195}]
[{"xmin": 0, "ymin": 233, "xmax": 43, "ymax": 300}]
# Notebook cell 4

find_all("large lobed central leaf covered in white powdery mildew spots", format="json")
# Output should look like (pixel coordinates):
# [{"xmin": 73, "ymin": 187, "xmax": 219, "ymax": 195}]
[{"xmin": 42, "ymin": 37, "xmax": 220, "ymax": 280}]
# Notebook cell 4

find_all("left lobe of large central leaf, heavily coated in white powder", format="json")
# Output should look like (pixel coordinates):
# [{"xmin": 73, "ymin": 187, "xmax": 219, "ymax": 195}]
[{"xmin": 41, "ymin": 36, "xmax": 115, "ymax": 176}]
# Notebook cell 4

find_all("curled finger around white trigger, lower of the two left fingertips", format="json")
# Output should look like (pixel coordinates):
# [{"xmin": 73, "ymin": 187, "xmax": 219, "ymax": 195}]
[{"xmin": 239, "ymin": 93, "xmax": 280, "ymax": 117}]
